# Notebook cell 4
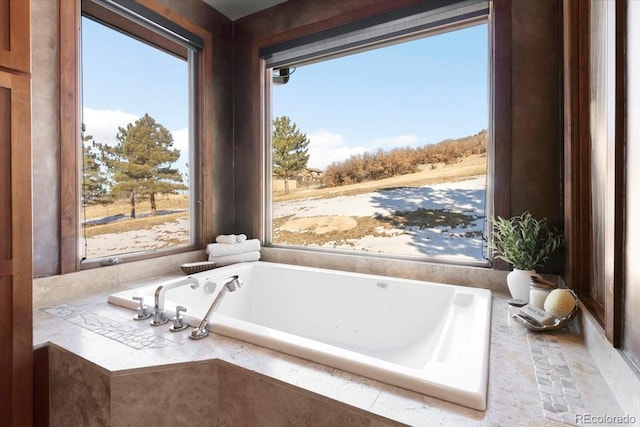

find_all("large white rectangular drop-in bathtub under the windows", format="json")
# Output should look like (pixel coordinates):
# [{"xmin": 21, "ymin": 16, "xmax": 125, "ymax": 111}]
[{"xmin": 109, "ymin": 261, "xmax": 491, "ymax": 410}]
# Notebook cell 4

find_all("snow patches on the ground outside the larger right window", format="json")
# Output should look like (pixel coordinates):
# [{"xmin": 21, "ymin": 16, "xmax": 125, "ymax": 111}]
[{"xmin": 273, "ymin": 176, "xmax": 486, "ymax": 261}]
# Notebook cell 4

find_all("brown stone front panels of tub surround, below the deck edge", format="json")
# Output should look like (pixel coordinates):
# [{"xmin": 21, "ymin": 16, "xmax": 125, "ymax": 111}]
[{"xmin": 38, "ymin": 344, "xmax": 400, "ymax": 427}]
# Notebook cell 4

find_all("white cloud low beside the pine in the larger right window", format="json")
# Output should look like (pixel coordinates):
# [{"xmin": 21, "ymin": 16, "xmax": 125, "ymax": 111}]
[{"xmin": 307, "ymin": 129, "xmax": 369, "ymax": 170}]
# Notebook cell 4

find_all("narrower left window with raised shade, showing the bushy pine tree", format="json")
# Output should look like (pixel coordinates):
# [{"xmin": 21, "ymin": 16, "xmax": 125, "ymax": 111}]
[{"xmin": 80, "ymin": 1, "xmax": 202, "ymax": 264}]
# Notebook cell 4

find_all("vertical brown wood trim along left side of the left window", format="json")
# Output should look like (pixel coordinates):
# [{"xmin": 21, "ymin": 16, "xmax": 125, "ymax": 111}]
[{"xmin": 59, "ymin": 0, "xmax": 80, "ymax": 274}]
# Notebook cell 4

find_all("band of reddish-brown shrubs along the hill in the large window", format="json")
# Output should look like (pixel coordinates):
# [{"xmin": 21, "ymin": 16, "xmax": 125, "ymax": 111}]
[{"xmin": 322, "ymin": 129, "xmax": 488, "ymax": 187}]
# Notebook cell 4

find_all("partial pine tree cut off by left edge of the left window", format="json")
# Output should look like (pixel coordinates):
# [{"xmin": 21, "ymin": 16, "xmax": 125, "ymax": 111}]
[{"xmin": 81, "ymin": 123, "xmax": 112, "ymax": 205}]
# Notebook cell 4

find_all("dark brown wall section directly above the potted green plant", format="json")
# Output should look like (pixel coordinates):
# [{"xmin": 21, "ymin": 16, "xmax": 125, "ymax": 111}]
[{"xmin": 510, "ymin": 0, "xmax": 563, "ymax": 228}]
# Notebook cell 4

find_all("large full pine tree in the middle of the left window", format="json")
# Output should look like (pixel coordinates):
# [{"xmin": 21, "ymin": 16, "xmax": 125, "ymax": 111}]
[{"xmin": 100, "ymin": 114, "xmax": 187, "ymax": 218}]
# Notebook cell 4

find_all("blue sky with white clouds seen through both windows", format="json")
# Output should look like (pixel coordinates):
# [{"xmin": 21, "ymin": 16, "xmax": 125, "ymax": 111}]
[{"xmin": 82, "ymin": 18, "xmax": 489, "ymax": 174}]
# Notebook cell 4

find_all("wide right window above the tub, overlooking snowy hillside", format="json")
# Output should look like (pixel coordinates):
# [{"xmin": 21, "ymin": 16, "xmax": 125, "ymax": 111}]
[{"xmin": 262, "ymin": 2, "xmax": 491, "ymax": 263}]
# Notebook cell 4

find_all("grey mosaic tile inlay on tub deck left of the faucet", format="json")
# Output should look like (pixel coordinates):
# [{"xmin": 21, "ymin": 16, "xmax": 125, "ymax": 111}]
[{"xmin": 40, "ymin": 304, "xmax": 180, "ymax": 349}]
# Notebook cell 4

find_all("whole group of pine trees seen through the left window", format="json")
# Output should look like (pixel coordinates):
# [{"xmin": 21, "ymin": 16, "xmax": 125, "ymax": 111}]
[{"xmin": 82, "ymin": 114, "xmax": 188, "ymax": 218}]
